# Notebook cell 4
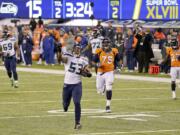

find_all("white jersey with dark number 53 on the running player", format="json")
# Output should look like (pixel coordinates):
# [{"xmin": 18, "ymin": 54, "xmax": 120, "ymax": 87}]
[{"xmin": 64, "ymin": 54, "xmax": 88, "ymax": 84}]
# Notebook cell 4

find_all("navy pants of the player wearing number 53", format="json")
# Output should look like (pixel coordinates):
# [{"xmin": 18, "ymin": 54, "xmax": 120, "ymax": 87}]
[{"xmin": 63, "ymin": 83, "xmax": 82, "ymax": 124}]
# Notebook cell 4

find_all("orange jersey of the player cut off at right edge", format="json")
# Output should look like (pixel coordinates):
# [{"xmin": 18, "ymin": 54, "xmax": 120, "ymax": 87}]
[{"xmin": 166, "ymin": 47, "xmax": 180, "ymax": 67}]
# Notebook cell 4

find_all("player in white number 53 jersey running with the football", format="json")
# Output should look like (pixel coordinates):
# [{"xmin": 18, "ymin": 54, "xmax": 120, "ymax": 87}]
[{"xmin": 62, "ymin": 44, "xmax": 91, "ymax": 129}]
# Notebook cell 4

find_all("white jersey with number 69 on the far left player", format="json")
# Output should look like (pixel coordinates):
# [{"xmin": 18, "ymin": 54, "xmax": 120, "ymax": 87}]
[{"xmin": 0, "ymin": 38, "xmax": 16, "ymax": 56}]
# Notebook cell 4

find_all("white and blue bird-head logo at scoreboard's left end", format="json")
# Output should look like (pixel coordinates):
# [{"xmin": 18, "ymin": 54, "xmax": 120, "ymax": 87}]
[{"xmin": 0, "ymin": 2, "xmax": 18, "ymax": 16}]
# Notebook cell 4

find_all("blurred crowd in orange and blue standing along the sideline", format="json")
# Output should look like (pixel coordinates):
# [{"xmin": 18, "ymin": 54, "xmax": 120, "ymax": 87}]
[{"xmin": 0, "ymin": 17, "xmax": 180, "ymax": 73}]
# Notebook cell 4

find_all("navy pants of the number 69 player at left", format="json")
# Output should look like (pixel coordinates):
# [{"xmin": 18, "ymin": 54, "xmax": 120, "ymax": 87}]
[{"xmin": 4, "ymin": 56, "xmax": 18, "ymax": 81}]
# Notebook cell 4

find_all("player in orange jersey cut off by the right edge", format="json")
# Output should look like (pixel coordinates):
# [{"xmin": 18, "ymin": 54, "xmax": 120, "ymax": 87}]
[{"xmin": 164, "ymin": 37, "xmax": 180, "ymax": 99}]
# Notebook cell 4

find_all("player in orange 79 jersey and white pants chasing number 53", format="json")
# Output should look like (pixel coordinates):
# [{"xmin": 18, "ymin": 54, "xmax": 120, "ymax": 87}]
[{"xmin": 94, "ymin": 38, "xmax": 122, "ymax": 112}]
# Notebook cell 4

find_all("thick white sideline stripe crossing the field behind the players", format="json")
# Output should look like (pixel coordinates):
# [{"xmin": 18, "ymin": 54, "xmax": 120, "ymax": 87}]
[{"xmin": 0, "ymin": 66, "xmax": 171, "ymax": 83}]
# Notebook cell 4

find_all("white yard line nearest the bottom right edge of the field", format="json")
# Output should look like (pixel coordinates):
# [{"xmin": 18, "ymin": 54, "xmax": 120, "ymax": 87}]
[{"xmin": 71, "ymin": 129, "xmax": 180, "ymax": 135}]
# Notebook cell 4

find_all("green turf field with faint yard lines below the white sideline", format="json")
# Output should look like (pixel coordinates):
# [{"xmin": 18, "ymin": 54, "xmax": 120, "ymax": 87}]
[{"xmin": 0, "ymin": 70, "xmax": 180, "ymax": 135}]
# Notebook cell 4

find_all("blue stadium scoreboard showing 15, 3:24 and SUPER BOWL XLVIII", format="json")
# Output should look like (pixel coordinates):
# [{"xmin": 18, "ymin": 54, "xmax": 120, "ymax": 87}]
[{"xmin": 0, "ymin": 0, "xmax": 180, "ymax": 20}]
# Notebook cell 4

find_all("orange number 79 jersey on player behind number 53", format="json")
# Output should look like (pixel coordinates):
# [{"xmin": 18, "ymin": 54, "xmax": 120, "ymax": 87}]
[{"xmin": 96, "ymin": 48, "xmax": 118, "ymax": 72}]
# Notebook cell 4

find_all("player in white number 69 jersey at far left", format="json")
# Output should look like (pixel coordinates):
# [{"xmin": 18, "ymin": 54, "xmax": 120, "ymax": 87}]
[{"xmin": 0, "ymin": 30, "xmax": 19, "ymax": 88}]
